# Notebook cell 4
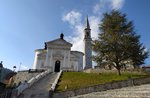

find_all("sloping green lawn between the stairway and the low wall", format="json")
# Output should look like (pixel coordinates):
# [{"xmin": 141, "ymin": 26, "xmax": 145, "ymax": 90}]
[{"xmin": 56, "ymin": 72, "xmax": 147, "ymax": 91}]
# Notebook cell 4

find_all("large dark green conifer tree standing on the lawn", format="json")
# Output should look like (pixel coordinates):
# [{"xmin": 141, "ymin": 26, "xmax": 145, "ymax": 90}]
[{"xmin": 92, "ymin": 10, "xmax": 149, "ymax": 75}]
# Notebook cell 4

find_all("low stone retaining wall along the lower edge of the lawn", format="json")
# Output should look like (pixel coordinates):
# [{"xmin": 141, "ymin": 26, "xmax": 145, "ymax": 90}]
[{"xmin": 50, "ymin": 77, "xmax": 150, "ymax": 98}]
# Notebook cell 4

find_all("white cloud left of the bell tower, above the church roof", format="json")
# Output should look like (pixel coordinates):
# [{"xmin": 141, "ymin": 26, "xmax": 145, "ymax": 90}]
[{"xmin": 62, "ymin": 10, "xmax": 84, "ymax": 51}]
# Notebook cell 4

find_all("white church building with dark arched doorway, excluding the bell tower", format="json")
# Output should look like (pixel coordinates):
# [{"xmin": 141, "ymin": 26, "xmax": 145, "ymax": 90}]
[{"xmin": 33, "ymin": 38, "xmax": 84, "ymax": 72}]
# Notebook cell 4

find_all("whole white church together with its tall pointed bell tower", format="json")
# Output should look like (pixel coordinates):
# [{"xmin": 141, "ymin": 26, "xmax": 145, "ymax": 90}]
[{"xmin": 33, "ymin": 17, "xmax": 92, "ymax": 72}]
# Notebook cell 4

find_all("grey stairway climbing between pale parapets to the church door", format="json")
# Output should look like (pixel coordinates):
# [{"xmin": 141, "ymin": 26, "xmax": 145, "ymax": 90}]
[{"xmin": 18, "ymin": 73, "xmax": 58, "ymax": 98}]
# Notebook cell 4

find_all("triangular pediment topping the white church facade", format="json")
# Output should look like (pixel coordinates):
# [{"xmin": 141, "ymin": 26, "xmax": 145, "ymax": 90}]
[{"xmin": 46, "ymin": 38, "xmax": 72, "ymax": 47}]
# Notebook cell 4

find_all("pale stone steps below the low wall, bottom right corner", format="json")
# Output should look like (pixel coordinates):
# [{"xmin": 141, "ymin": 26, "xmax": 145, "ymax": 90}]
[{"xmin": 71, "ymin": 84, "xmax": 150, "ymax": 98}]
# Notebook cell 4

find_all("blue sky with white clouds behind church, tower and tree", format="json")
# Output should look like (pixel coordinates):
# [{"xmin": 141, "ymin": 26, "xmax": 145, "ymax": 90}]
[{"xmin": 0, "ymin": 0, "xmax": 150, "ymax": 69}]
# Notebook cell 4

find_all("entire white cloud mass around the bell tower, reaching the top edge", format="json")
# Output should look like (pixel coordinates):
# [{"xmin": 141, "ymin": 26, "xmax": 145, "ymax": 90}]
[{"xmin": 62, "ymin": 0, "xmax": 124, "ymax": 52}]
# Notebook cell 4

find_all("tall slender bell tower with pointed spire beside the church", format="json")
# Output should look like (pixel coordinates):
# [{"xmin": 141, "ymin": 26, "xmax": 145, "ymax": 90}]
[{"xmin": 84, "ymin": 16, "xmax": 92, "ymax": 69}]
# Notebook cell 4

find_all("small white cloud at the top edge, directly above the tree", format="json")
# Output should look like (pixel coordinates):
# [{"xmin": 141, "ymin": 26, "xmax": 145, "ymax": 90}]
[{"xmin": 111, "ymin": 0, "xmax": 124, "ymax": 10}]
